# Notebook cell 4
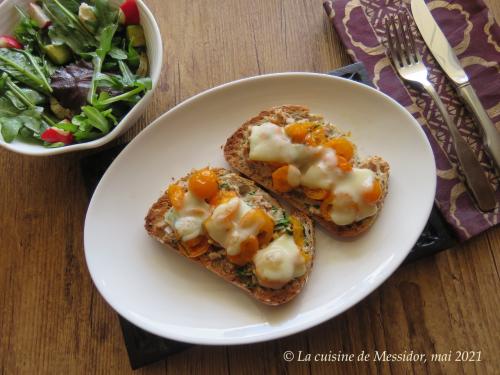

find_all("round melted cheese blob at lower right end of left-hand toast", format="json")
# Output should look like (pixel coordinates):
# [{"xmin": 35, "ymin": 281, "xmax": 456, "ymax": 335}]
[{"xmin": 253, "ymin": 234, "xmax": 306, "ymax": 289}]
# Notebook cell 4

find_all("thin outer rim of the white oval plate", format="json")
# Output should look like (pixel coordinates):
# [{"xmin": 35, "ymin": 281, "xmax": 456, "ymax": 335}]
[{"xmin": 83, "ymin": 72, "xmax": 437, "ymax": 346}]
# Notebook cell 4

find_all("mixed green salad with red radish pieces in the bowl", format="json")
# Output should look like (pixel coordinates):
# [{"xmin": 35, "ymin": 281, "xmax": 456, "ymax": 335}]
[{"xmin": 0, "ymin": 0, "xmax": 151, "ymax": 147}]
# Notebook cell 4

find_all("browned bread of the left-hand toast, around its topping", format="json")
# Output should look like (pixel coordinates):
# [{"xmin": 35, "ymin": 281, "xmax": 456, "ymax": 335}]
[{"xmin": 145, "ymin": 168, "xmax": 314, "ymax": 305}]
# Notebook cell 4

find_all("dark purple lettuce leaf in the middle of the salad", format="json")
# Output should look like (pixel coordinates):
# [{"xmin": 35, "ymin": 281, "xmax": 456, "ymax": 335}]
[{"xmin": 51, "ymin": 61, "xmax": 94, "ymax": 113}]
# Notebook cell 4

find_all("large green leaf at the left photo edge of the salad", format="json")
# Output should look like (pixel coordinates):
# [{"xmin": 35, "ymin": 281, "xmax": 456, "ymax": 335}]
[{"xmin": 0, "ymin": 48, "xmax": 52, "ymax": 94}]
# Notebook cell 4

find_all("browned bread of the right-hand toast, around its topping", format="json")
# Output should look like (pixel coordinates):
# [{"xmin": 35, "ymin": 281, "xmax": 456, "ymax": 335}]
[{"xmin": 224, "ymin": 105, "xmax": 389, "ymax": 237}]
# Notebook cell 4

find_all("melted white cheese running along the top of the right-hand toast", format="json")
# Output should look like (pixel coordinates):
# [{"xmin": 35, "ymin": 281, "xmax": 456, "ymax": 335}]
[{"xmin": 249, "ymin": 122, "xmax": 377, "ymax": 225}]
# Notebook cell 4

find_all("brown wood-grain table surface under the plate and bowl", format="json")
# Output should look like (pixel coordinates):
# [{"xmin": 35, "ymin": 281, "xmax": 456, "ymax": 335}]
[{"xmin": 0, "ymin": 0, "xmax": 500, "ymax": 375}]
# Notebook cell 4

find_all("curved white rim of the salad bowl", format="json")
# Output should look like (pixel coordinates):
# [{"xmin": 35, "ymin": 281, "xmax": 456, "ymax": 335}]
[{"xmin": 0, "ymin": 0, "xmax": 163, "ymax": 156}]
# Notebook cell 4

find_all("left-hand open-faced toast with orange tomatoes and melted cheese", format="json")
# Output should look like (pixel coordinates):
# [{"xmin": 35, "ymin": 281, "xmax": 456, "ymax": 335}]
[{"xmin": 145, "ymin": 168, "xmax": 314, "ymax": 305}]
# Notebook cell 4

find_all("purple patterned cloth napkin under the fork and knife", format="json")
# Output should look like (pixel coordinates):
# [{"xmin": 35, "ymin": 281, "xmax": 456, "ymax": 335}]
[{"xmin": 323, "ymin": 0, "xmax": 500, "ymax": 240}]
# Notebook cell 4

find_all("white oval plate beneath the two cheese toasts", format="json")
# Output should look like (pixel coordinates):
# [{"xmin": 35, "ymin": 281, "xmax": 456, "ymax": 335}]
[{"xmin": 84, "ymin": 73, "xmax": 436, "ymax": 345}]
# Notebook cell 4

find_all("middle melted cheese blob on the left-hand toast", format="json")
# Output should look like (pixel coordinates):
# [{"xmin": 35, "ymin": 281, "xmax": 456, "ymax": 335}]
[{"xmin": 205, "ymin": 197, "xmax": 254, "ymax": 255}]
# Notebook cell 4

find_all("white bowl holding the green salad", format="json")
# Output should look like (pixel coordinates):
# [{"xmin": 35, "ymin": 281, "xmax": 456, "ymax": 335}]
[{"xmin": 0, "ymin": 0, "xmax": 163, "ymax": 156}]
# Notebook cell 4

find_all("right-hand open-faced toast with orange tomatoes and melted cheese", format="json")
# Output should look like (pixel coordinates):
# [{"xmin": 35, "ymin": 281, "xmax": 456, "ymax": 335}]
[{"xmin": 224, "ymin": 105, "xmax": 389, "ymax": 237}]
